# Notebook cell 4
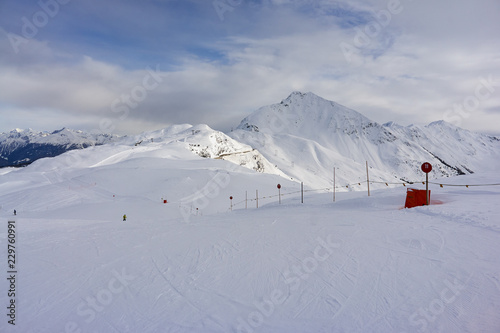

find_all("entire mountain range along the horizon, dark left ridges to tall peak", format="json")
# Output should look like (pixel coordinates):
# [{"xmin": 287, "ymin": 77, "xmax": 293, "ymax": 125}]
[{"xmin": 0, "ymin": 92, "xmax": 500, "ymax": 188}]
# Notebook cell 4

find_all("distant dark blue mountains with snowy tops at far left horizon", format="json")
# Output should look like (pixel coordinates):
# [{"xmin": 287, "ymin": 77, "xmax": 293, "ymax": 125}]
[{"xmin": 0, "ymin": 128, "xmax": 117, "ymax": 168}]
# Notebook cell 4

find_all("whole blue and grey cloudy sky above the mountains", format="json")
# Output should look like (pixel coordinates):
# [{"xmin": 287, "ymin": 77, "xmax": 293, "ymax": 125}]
[{"xmin": 0, "ymin": 0, "xmax": 500, "ymax": 134}]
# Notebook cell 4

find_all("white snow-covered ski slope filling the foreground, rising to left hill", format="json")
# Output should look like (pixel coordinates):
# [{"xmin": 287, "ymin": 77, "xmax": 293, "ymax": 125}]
[{"xmin": 0, "ymin": 125, "xmax": 500, "ymax": 333}]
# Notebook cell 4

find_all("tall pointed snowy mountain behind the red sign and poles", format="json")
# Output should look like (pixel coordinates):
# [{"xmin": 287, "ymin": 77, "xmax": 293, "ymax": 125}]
[{"xmin": 230, "ymin": 92, "xmax": 499, "ymax": 188}]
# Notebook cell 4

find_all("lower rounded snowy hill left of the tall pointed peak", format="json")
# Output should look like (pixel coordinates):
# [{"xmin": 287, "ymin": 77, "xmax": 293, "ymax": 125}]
[{"xmin": 0, "ymin": 124, "xmax": 296, "ymax": 219}]
